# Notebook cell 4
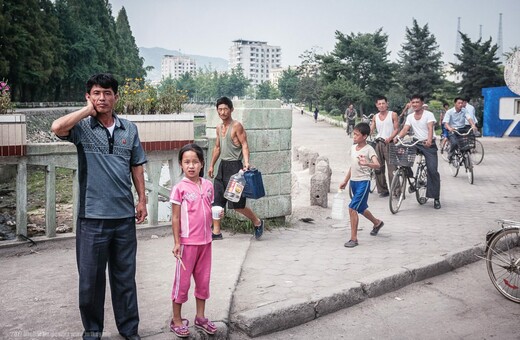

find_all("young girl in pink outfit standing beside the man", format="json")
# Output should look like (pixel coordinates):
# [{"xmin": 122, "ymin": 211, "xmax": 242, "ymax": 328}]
[{"xmin": 170, "ymin": 144, "xmax": 217, "ymax": 338}]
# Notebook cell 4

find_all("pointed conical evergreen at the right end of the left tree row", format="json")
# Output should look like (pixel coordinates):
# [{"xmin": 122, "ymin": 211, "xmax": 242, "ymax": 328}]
[{"xmin": 116, "ymin": 7, "xmax": 146, "ymax": 78}]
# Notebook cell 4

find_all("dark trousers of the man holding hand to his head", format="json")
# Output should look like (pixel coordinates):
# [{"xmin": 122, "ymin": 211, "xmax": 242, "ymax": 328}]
[{"xmin": 76, "ymin": 217, "xmax": 139, "ymax": 338}]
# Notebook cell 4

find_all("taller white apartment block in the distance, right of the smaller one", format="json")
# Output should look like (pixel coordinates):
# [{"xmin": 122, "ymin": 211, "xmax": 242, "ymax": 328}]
[{"xmin": 229, "ymin": 39, "xmax": 282, "ymax": 85}]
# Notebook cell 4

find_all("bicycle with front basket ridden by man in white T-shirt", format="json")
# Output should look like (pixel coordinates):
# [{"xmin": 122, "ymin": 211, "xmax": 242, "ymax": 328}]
[{"xmin": 388, "ymin": 137, "xmax": 428, "ymax": 214}]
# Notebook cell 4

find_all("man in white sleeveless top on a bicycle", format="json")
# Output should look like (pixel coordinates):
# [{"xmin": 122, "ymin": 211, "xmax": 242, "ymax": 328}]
[{"xmin": 370, "ymin": 96, "xmax": 399, "ymax": 197}]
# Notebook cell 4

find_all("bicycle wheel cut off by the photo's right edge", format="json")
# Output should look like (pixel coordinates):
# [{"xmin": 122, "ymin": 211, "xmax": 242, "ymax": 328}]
[{"xmin": 486, "ymin": 227, "xmax": 520, "ymax": 303}]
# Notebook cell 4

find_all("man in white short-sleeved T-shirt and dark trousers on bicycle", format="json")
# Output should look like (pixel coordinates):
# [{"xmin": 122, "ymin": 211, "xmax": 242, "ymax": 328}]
[{"xmin": 398, "ymin": 94, "xmax": 441, "ymax": 209}]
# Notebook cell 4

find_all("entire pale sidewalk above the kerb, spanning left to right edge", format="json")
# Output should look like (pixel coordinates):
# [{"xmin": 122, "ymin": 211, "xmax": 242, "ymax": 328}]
[{"xmin": 0, "ymin": 111, "xmax": 520, "ymax": 340}]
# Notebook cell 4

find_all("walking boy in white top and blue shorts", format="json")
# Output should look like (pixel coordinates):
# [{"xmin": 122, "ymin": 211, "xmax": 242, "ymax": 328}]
[{"xmin": 339, "ymin": 123, "xmax": 384, "ymax": 248}]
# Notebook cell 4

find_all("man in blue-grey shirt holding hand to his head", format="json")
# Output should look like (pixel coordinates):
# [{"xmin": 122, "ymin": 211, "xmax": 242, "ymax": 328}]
[{"xmin": 51, "ymin": 73, "xmax": 148, "ymax": 340}]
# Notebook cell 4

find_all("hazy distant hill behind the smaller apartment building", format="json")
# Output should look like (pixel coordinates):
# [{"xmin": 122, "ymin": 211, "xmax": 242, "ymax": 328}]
[{"xmin": 139, "ymin": 47, "xmax": 228, "ymax": 81}]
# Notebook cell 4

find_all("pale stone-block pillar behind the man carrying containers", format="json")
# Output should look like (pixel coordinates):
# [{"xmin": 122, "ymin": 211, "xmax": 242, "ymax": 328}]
[{"xmin": 206, "ymin": 100, "xmax": 292, "ymax": 218}]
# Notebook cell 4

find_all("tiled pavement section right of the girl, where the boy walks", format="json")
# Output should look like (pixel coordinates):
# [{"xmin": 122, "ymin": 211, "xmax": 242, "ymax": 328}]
[{"xmin": 231, "ymin": 111, "xmax": 520, "ymax": 335}]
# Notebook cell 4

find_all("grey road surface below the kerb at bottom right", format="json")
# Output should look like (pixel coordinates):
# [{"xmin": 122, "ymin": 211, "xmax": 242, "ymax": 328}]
[{"xmin": 230, "ymin": 261, "xmax": 520, "ymax": 340}]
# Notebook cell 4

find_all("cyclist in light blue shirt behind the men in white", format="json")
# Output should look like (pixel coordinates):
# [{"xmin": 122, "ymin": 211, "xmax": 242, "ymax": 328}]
[{"xmin": 442, "ymin": 97, "xmax": 477, "ymax": 162}]
